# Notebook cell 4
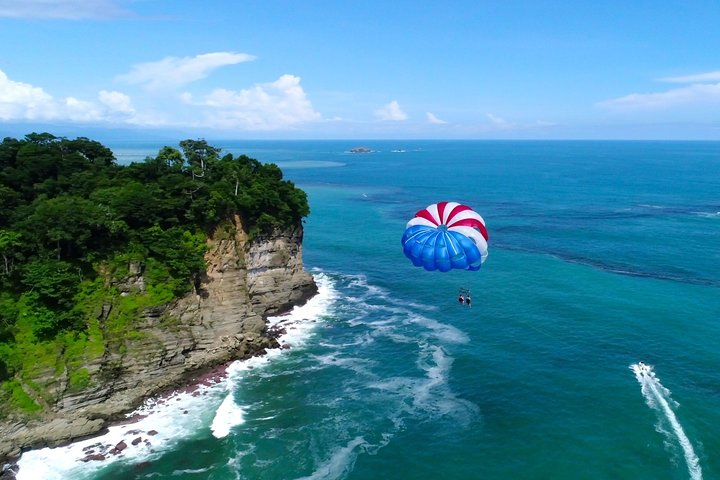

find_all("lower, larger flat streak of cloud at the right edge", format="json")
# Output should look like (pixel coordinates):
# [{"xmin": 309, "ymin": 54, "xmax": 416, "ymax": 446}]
[{"xmin": 597, "ymin": 83, "xmax": 720, "ymax": 110}]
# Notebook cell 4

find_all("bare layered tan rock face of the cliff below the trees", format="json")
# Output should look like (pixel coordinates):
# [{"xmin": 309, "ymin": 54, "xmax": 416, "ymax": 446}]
[{"xmin": 0, "ymin": 217, "xmax": 317, "ymax": 460}]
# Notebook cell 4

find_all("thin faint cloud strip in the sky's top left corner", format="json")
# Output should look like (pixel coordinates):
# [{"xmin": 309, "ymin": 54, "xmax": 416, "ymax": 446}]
[{"xmin": 0, "ymin": 0, "xmax": 130, "ymax": 20}]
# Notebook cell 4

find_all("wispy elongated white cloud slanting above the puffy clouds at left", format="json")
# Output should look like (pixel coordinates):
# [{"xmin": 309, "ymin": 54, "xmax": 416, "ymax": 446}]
[{"xmin": 116, "ymin": 52, "xmax": 255, "ymax": 90}]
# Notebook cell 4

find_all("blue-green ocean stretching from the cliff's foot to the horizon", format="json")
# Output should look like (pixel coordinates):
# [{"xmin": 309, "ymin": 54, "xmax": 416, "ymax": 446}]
[{"xmin": 12, "ymin": 140, "xmax": 720, "ymax": 480}]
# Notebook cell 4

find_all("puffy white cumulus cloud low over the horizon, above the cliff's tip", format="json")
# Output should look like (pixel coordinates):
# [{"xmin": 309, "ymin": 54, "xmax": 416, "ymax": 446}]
[{"xmin": 180, "ymin": 75, "xmax": 322, "ymax": 130}]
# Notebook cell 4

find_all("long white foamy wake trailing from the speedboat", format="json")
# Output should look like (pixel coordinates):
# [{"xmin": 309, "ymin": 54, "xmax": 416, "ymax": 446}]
[{"xmin": 630, "ymin": 362, "xmax": 702, "ymax": 480}]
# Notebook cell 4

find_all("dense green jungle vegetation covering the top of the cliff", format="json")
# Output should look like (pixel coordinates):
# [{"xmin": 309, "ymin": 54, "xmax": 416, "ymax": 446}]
[{"xmin": 0, "ymin": 133, "xmax": 309, "ymax": 417}]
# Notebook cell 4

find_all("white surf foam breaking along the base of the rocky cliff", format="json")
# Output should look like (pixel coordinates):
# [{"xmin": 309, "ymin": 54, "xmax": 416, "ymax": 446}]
[{"xmin": 17, "ymin": 273, "xmax": 337, "ymax": 480}]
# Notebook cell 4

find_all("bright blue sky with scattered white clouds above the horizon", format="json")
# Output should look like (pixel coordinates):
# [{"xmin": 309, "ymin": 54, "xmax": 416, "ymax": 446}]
[{"xmin": 0, "ymin": 0, "xmax": 720, "ymax": 140}]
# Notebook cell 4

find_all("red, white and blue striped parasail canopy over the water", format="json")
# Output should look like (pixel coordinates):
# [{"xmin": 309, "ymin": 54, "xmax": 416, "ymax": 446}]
[{"xmin": 402, "ymin": 202, "xmax": 488, "ymax": 272}]
